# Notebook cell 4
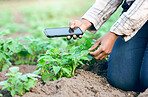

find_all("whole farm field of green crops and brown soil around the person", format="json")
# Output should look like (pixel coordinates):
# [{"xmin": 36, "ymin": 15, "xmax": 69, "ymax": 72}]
[{"xmin": 0, "ymin": 0, "xmax": 148, "ymax": 97}]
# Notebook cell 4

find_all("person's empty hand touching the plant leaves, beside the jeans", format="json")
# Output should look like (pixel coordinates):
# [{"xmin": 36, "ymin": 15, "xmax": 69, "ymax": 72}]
[{"xmin": 89, "ymin": 32, "xmax": 119, "ymax": 60}]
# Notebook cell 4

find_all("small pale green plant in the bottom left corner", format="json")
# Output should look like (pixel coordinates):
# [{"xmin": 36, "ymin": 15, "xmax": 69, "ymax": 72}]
[{"xmin": 0, "ymin": 67, "xmax": 40, "ymax": 96}]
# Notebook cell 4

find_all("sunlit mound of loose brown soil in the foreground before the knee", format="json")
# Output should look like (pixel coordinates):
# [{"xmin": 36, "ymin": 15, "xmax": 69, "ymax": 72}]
[{"xmin": 23, "ymin": 69, "xmax": 136, "ymax": 97}]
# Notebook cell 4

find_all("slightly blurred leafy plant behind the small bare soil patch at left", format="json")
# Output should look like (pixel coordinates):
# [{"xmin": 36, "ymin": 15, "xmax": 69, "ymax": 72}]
[{"xmin": 3, "ymin": 37, "xmax": 51, "ymax": 65}]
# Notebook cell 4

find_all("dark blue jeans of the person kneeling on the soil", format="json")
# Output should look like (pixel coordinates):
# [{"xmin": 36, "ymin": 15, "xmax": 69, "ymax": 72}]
[{"xmin": 107, "ymin": 22, "xmax": 148, "ymax": 91}]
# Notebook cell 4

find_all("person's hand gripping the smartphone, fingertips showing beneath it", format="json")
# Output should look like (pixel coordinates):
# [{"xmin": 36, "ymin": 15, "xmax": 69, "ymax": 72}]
[{"xmin": 67, "ymin": 19, "xmax": 92, "ymax": 40}]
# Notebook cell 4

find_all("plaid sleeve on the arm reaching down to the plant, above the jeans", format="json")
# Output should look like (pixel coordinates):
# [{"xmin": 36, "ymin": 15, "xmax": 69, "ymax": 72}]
[{"xmin": 110, "ymin": 0, "xmax": 148, "ymax": 41}]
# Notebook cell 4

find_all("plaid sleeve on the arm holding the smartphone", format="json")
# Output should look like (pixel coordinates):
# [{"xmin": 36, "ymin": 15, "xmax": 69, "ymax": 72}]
[{"xmin": 82, "ymin": 0, "xmax": 123, "ymax": 31}]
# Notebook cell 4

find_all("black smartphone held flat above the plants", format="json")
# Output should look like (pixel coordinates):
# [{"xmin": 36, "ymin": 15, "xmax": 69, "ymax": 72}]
[{"xmin": 44, "ymin": 27, "xmax": 83, "ymax": 38}]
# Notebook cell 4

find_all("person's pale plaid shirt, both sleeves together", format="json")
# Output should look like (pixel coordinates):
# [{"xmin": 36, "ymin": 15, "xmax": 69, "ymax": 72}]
[{"xmin": 82, "ymin": 0, "xmax": 148, "ymax": 41}]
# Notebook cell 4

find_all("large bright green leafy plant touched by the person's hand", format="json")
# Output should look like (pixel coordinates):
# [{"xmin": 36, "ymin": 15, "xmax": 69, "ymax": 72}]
[{"xmin": 37, "ymin": 46, "xmax": 89, "ymax": 82}]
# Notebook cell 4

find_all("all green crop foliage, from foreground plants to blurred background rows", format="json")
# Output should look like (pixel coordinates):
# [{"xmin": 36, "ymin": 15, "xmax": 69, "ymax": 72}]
[{"xmin": 0, "ymin": 0, "xmax": 121, "ymax": 96}]
